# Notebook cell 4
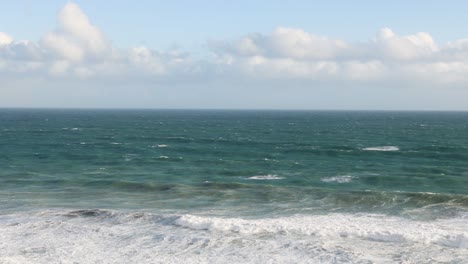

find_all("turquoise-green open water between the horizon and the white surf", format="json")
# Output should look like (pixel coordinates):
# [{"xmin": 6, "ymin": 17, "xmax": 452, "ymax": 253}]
[{"xmin": 0, "ymin": 110, "xmax": 468, "ymax": 217}]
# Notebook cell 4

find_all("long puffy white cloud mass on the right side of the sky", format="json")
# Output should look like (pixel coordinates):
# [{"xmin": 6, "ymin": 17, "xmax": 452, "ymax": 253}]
[{"xmin": 209, "ymin": 27, "xmax": 468, "ymax": 83}]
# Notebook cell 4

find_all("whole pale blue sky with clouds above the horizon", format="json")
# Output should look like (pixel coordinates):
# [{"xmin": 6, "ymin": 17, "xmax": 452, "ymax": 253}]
[{"xmin": 0, "ymin": 0, "xmax": 468, "ymax": 110}]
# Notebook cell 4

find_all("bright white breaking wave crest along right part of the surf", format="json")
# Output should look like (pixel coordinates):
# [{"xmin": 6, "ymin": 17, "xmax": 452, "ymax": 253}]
[{"xmin": 174, "ymin": 214, "xmax": 468, "ymax": 249}]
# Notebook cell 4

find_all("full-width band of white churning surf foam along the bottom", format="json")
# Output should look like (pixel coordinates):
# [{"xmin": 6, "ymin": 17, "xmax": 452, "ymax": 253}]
[{"xmin": 0, "ymin": 210, "xmax": 468, "ymax": 263}]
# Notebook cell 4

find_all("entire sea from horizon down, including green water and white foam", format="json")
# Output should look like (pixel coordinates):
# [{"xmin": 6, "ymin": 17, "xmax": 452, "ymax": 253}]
[{"xmin": 0, "ymin": 109, "xmax": 468, "ymax": 264}]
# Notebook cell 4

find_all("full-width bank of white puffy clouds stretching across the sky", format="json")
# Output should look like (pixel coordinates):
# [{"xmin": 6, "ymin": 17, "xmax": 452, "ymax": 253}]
[{"xmin": 0, "ymin": 2, "xmax": 468, "ymax": 109}]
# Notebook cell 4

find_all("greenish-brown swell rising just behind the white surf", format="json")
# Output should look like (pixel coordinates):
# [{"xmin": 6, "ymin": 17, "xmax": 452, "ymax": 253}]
[{"xmin": 0, "ymin": 179, "xmax": 468, "ymax": 219}]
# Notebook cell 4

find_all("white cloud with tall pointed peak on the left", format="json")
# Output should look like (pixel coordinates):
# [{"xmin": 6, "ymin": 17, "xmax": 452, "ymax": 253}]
[{"xmin": 0, "ymin": 2, "xmax": 189, "ymax": 79}]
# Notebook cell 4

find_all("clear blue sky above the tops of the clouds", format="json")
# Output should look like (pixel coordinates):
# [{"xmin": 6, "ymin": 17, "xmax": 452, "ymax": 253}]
[{"xmin": 4, "ymin": 0, "xmax": 468, "ymax": 49}]
